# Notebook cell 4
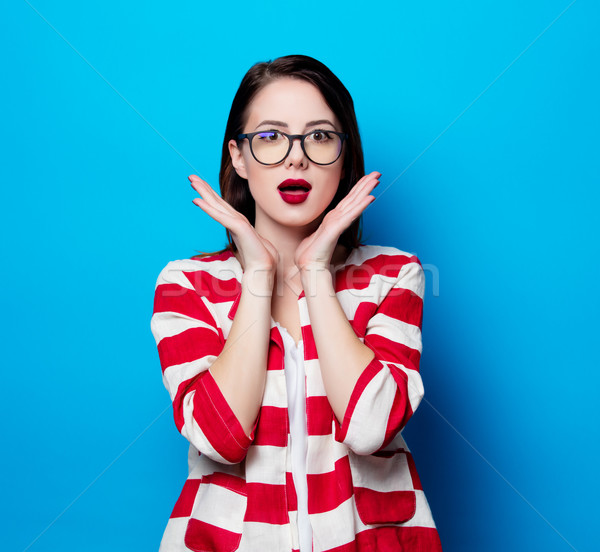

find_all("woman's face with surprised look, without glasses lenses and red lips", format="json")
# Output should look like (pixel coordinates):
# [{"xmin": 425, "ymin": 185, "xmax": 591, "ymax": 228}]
[{"xmin": 229, "ymin": 77, "xmax": 345, "ymax": 231}]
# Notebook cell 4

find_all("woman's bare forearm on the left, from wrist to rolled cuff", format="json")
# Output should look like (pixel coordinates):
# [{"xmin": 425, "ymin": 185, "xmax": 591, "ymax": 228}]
[{"xmin": 210, "ymin": 271, "xmax": 273, "ymax": 435}]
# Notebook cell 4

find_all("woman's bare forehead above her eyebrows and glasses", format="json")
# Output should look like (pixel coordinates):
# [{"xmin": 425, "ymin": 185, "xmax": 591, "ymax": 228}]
[{"xmin": 246, "ymin": 78, "xmax": 339, "ymax": 132}]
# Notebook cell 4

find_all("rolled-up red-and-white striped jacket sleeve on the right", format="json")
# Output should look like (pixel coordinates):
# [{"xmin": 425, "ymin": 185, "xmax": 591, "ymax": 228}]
[{"xmin": 334, "ymin": 255, "xmax": 425, "ymax": 455}]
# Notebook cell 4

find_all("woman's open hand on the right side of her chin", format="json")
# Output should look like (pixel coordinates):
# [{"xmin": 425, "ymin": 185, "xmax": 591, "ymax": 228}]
[{"xmin": 294, "ymin": 171, "xmax": 381, "ymax": 272}]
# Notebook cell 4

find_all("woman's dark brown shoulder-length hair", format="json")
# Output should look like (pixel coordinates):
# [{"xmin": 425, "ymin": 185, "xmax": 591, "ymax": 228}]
[{"xmin": 199, "ymin": 55, "xmax": 364, "ymax": 251}]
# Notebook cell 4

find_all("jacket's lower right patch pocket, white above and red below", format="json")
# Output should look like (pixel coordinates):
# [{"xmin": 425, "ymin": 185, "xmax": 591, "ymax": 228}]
[{"xmin": 348, "ymin": 450, "xmax": 417, "ymax": 525}]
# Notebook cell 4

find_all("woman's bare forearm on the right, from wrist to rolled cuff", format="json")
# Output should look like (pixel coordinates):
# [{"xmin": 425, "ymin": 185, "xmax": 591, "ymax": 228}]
[{"xmin": 301, "ymin": 269, "xmax": 375, "ymax": 424}]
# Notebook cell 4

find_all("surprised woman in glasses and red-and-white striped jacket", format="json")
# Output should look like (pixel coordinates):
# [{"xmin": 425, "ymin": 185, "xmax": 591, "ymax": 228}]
[{"xmin": 152, "ymin": 56, "xmax": 441, "ymax": 552}]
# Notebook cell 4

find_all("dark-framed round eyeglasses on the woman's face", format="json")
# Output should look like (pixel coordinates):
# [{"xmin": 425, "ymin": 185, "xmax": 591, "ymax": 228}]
[{"xmin": 237, "ymin": 130, "xmax": 348, "ymax": 165}]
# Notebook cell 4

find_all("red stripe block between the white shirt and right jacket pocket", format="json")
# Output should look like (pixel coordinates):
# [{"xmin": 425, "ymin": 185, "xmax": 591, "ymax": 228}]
[{"xmin": 306, "ymin": 456, "xmax": 352, "ymax": 514}]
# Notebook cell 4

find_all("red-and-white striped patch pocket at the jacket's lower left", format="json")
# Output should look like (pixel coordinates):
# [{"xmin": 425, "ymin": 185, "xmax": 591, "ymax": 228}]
[{"xmin": 184, "ymin": 472, "xmax": 248, "ymax": 552}]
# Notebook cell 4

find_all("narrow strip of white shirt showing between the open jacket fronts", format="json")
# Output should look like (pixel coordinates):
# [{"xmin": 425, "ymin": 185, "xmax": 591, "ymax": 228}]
[{"xmin": 275, "ymin": 322, "xmax": 312, "ymax": 552}]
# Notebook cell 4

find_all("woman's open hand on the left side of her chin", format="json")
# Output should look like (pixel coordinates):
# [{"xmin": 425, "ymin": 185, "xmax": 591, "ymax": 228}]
[{"xmin": 188, "ymin": 174, "xmax": 279, "ymax": 276}]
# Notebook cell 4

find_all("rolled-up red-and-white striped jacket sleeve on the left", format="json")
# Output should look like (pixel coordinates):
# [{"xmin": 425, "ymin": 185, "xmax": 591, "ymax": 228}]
[{"xmin": 151, "ymin": 261, "xmax": 256, "ymax": 464}]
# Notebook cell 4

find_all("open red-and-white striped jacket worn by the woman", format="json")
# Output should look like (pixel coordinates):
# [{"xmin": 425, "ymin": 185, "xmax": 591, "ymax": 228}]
[{"xmin": 151, "ymin": 246, "xmax": 441, "ymax": 552}]
